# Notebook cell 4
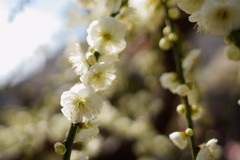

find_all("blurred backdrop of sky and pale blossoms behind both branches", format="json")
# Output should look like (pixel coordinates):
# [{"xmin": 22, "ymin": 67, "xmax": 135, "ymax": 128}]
[{"xmin": 0, "ymin": 0, "xmax": 240, "ymax": 160}]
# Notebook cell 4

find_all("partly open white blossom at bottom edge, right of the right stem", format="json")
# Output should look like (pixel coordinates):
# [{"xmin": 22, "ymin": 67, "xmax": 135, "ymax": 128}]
[{"xmin": 196, "ymin": 138, "xmax": 221, "ymax": 160}]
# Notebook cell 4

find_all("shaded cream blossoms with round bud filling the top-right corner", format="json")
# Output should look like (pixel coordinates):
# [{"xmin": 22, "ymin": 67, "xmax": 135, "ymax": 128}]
[{"xmin": 178, "ymin": 0, "xmax": 240, "ymax": 61}]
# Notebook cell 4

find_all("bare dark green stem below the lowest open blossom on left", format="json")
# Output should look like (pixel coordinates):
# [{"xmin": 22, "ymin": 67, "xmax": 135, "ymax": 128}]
[{"xmin": 63, "ymin": 123, "xmax": 79, "ymax": 160}]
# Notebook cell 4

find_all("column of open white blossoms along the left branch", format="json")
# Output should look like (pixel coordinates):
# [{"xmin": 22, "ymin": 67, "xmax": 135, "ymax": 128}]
[{"xmin": 58, "ymin": 0, "xmax": 131, "ymax": 159}]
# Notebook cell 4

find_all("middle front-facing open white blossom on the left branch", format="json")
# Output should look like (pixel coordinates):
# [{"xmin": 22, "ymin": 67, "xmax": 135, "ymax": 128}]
[{"xmin": 80, "ymin": 62, "xmax": 116, "ymax": 92}]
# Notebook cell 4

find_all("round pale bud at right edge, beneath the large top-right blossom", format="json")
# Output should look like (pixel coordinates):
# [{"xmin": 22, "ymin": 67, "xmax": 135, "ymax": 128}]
[{"xmin": 224, "ymin": 46, "xmax": 240, "ymax": 61}]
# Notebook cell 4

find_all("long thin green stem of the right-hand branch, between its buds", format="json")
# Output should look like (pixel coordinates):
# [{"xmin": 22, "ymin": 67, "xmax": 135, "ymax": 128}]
[{"xmin": 163, "ymin": 1, "xmax": 198, "ymax": 160}]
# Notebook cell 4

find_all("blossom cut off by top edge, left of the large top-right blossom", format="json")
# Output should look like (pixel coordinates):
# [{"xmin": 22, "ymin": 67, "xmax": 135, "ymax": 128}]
[{"xmin": 177, "ymin": 0, "xmax": 205, "ymax": 14}]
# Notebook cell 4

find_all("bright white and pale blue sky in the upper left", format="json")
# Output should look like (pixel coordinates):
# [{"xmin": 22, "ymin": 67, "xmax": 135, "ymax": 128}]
[{"xmin": 0, "ymin": 0, "xmax": 71, "ymax": 86}]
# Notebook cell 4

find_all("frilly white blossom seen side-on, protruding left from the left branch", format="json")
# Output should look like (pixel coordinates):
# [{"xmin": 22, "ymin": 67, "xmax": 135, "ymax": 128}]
[{"xmin": 66, "ymin": 43, "xmax": 89, "ymax": 75}]
